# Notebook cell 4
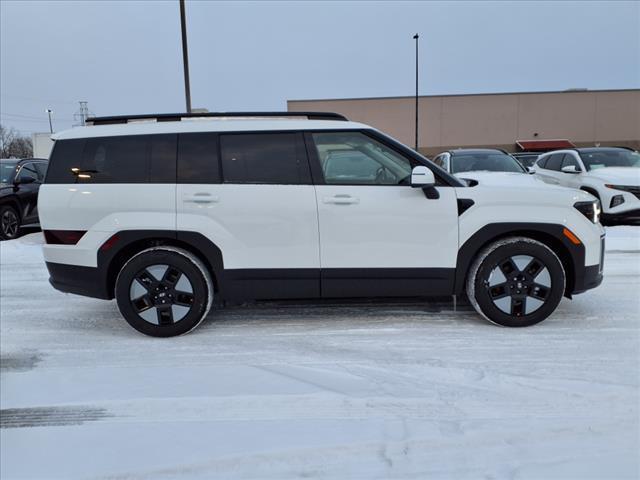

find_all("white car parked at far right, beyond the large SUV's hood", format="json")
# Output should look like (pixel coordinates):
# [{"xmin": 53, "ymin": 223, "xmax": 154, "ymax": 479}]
[{"xmin": 534, "ymin": 147, "xmax": 640, "ymax": 225}]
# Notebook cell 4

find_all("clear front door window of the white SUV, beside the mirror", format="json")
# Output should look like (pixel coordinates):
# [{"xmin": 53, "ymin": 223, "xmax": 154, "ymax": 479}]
[{"xmin": 312, "ymin": 132, "xmax": 411, "ymax": 185}]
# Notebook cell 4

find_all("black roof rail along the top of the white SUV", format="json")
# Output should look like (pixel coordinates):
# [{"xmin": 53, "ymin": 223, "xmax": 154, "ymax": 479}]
[{"xmin": 85, "ymin": 112, "xmax": 348, "ymax": 125}]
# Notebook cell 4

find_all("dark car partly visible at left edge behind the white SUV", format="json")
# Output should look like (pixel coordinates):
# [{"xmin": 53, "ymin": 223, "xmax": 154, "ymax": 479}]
[{"xmin": 0, "ymin": 158, "xmax": 47, "ymax": 240}]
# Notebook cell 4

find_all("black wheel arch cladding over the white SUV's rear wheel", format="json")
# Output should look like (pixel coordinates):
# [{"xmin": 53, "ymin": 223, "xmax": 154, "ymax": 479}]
[{"xmin": 98, "ymin": 230, "xmax": 224, "ymax": 298}]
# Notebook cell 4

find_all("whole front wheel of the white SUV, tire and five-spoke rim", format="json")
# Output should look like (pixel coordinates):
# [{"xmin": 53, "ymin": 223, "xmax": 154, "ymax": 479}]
[{"xmin": 467, "ymin": 237, "xmax": 566, "ymax": 327}]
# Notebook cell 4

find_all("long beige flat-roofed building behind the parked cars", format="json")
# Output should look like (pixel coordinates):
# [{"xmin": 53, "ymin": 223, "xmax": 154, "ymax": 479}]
[{"xmin": 287, "ymin": 89, "xmax": 640, "ymax": 155}]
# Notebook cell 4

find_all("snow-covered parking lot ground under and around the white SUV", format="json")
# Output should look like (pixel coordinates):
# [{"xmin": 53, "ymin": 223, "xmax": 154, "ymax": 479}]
[{"xmin": 0, "ymin": 227, "xmax": 640, "ymax": 479}]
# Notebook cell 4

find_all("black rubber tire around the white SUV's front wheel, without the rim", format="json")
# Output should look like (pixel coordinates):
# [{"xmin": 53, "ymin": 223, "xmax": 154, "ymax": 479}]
[{"xmin": 473, "ymin": 240, "xmax": 565, "ymax": 327}]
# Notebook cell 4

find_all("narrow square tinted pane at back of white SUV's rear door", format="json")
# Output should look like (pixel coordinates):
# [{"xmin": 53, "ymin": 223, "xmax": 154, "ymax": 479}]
[{"xmin": 178, "ymin": 133, "xmax": 220, "ymax": 183}]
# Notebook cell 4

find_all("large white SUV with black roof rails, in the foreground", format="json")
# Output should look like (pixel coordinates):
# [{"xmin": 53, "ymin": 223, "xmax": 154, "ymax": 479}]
[{"xmin": 38, "ymin": 113, "xmax": 604, "ymax": 337}]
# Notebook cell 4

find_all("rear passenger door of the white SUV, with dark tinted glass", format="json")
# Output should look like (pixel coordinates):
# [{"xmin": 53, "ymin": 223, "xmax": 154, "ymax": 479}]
[{"xmin": 177, "ymin": 132, "xmax": 320, "ymax": 299}]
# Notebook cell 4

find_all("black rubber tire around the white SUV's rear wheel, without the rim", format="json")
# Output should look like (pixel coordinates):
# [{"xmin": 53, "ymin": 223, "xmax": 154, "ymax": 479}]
[{"xmin": 115, "ymin": 248, "xmax": 210, "ymax": 337}]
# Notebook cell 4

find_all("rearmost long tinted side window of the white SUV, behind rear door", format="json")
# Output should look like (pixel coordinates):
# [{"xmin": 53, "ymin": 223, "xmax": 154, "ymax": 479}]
[{"xmin": 46, "ymin": 134, "xmax": 177, "ymax": 183}]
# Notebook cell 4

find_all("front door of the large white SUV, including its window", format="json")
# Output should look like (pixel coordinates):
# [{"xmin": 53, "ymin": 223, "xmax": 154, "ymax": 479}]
[{"xmin": 307, "ymin": 131, "xmax": 458, "ymax": 297}]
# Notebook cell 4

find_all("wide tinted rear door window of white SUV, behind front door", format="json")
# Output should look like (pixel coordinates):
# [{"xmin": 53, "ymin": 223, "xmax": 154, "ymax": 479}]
[{"xmin": 220, "ymin": 133, "xmax": 311, "ymax": 185}]
